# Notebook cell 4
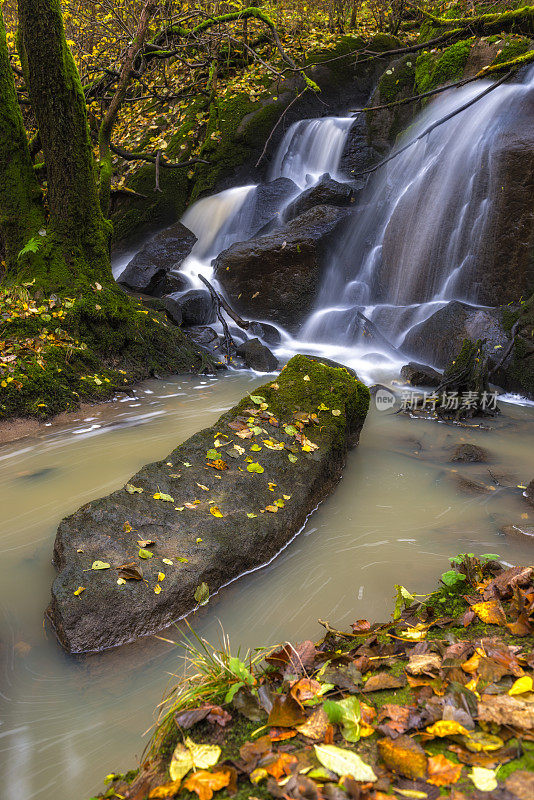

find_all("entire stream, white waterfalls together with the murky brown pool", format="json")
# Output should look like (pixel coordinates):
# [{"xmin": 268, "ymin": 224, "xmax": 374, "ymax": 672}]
[{"xmin": 0, "ymin": 72, "xmax": 534, "ymax": 800}]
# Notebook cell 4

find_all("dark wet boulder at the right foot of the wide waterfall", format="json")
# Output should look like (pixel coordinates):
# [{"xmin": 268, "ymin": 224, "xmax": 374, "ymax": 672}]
[{"xmin": 400, "ymin": 300, "xmax": 507, "ymax": 369}]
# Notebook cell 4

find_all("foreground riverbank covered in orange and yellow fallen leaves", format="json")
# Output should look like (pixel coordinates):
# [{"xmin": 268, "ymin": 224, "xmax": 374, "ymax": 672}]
[{"xmin": 94, "ymin": 554, "xmax": 534, "ymax": 800}]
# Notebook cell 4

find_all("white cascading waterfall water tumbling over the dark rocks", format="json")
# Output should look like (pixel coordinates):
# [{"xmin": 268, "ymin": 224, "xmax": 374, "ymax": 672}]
[{"xmin": 168, "ymin": 70, "xmax": 534, "ymax": 382}]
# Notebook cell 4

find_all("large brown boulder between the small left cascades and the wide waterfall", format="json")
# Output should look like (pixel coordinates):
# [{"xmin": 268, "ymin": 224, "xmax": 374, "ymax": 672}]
[{"xmin": 214, "ymin": 206, "xmax": 356, "ymax": 330}]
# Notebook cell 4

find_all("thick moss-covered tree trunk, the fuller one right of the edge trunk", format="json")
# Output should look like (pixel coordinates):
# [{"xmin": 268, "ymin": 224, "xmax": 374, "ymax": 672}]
[{"xmin": 18, "ymin": 0, "xmax": 112, "ymax": 291}]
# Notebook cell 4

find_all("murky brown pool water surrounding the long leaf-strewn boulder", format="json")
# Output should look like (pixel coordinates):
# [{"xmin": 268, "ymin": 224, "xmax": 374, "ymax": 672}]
[{"xmin": 0, "ymin": 373, "xmax": 534, "ymax": 800}]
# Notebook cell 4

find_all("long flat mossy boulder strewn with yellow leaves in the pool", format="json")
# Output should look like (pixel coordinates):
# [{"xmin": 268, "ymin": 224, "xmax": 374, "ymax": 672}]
[{"xmin": 48, "ymin": 356, "xmax": 369, "ymax": 653}]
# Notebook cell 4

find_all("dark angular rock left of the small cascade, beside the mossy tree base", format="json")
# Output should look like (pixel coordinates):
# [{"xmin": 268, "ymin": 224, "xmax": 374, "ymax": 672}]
[{"xmin": 118, "ymin": 222, "xmax": 197, "ymax": 294}]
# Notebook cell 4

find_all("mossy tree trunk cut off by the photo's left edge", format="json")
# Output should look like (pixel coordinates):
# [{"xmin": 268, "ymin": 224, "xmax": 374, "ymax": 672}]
[{"xmin": 0, "ymin": 11, "xmax": 45, "ymax": 273}]
